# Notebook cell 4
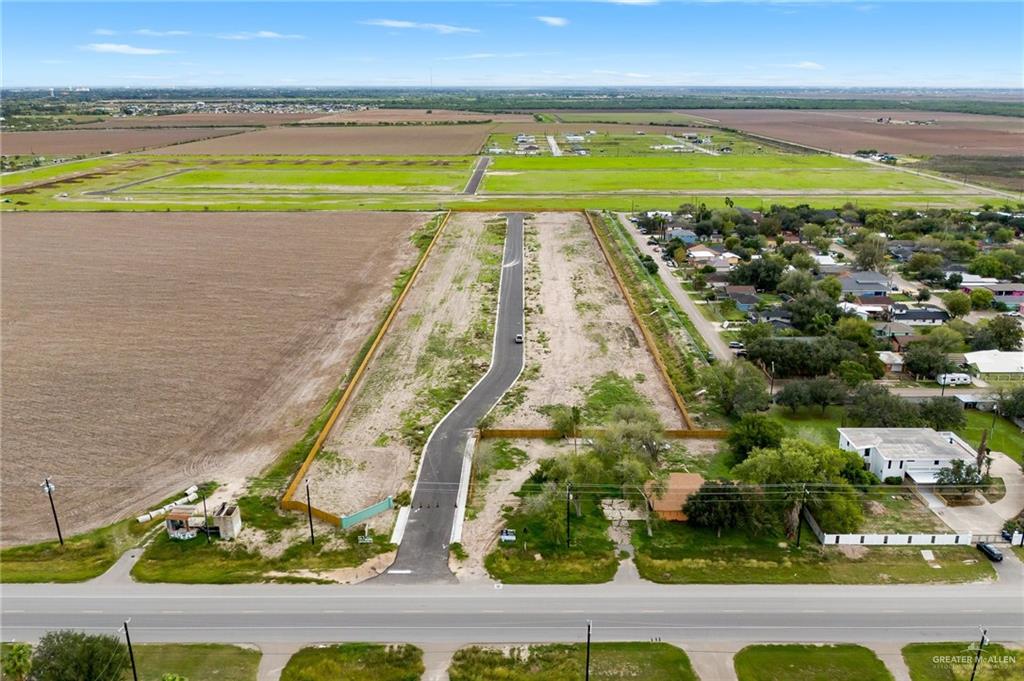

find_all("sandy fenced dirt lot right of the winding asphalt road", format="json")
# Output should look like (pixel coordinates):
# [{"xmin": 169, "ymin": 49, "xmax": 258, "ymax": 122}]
[{"xmin": 497, "ymin": 213, "xmax": 682, "ymax": 428}]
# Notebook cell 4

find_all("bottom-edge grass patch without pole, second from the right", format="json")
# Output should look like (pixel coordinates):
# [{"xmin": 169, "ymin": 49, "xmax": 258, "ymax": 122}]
[{"xmin": 734, "ymin": 645, "xmax": 893, "ymax": 681}]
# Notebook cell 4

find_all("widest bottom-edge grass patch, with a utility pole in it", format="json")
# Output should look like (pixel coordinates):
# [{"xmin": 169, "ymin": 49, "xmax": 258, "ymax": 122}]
[{"xmin": 449, "ymin": 643, "xmax": 697, "ymax": 681}]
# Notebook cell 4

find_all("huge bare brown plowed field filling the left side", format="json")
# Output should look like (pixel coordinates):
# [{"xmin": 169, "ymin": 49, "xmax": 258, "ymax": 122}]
[{"xmin": 0, "ymin": 213, "xmax": 428, "ymax": 544}]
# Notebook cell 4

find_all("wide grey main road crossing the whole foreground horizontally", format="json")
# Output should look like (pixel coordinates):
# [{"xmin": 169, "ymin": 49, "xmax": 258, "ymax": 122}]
[{"xmin": 0, "ymin": 577, "xmax": 1024, "ymax": 644}]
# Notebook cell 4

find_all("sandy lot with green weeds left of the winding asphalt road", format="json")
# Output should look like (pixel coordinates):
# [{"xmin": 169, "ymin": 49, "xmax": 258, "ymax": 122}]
[{"xmin": 300, "ymin": 213, "xmax": 505, "ymax": 529}]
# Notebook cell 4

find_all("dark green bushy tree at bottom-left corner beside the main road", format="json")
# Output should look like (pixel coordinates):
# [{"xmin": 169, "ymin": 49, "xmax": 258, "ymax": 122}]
[{"xmin": 32, "ymin": 631, "xmax": 128, "ymax": 681}]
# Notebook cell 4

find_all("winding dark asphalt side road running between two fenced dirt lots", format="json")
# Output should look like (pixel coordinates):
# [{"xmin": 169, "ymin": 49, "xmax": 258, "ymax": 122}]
[{"xmin": 385, "ymin": 213, "xmax": 524, "ymax": 583}]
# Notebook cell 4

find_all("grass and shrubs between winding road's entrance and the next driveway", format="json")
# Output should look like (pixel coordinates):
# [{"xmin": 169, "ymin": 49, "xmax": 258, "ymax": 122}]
[{"xmin": 484, "ymin": 489, "xmax": 618, "ymax": 584}]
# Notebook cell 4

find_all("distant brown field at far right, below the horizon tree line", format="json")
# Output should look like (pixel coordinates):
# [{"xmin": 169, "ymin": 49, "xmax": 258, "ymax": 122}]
[{"xmin": 680, "ymin": 109, "xmax": 1024, "ymax": 156}]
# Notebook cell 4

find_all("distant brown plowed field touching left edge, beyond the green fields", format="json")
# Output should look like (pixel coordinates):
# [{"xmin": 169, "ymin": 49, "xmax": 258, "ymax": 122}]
[{"xmin": 0, "ymin": 128, "xmax": 244, "ymax": 156}]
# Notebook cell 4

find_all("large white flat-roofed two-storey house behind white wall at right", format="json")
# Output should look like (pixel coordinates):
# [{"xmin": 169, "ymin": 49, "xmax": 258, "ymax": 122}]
[{"xmin": 839, "ymin": 428, "xmax": 977, "ymax": 484}]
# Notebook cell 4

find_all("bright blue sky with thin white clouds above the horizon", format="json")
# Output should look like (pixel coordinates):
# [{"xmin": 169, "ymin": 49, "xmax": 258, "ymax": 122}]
[{"xmin": 2, "ymin": 0, "xmax": 1024, "ymax": 87}]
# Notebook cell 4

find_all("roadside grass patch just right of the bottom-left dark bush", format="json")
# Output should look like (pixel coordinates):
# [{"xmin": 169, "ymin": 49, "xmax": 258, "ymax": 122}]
[{"xmin": 130, "ymin": 643, "xmax": 261, "ymax": 681}]
